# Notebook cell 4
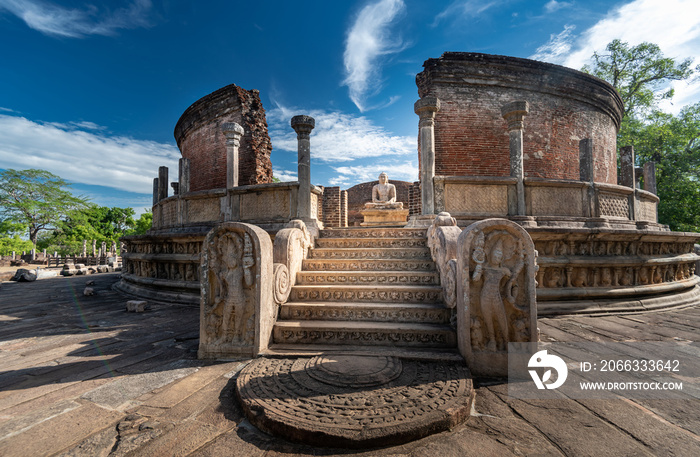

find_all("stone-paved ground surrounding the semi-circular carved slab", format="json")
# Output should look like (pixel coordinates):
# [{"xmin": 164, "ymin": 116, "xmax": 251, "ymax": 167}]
[{"xmin": 0, "ymin": 274, "xmax": 700, "ymax": 457}]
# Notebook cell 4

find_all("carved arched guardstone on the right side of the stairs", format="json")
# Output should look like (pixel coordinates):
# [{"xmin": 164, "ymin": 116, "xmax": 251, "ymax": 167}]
[{"xmin": 456, "ymin": 219, "xmax": 537, "ymax": 376}]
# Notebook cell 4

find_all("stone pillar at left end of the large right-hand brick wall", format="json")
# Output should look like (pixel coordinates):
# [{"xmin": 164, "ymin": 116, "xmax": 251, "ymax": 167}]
[{"xmin": 413, "ymin": 95, "xmax": 440, "ymax": 215}]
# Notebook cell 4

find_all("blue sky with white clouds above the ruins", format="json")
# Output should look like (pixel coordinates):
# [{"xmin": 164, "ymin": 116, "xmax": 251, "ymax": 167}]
[{"xmin": 0, "ymin": 0, "xmax": 700, "ymax": 213}]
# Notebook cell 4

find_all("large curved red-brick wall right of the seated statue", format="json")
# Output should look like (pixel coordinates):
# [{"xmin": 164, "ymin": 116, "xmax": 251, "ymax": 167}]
[{"xmin": 416, "ymin": 52, "xmax": 622, "ymax": 184}]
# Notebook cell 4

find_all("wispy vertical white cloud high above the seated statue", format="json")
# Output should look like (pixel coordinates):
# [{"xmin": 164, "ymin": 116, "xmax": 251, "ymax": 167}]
[{"xmin": 343, "ymin": 0, "xmax": 406, "ymax": 112}]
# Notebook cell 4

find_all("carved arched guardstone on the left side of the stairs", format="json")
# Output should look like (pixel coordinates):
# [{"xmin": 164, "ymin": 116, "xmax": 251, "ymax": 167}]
[{"xmin": 198, "ymin": 222, "xmax": 276, "ymax": 358}]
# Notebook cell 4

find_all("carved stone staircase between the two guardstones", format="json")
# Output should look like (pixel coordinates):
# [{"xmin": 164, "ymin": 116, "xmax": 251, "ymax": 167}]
[{"xmin": 271, "ymin": 228, "xmax": 457, "ymax": 353}]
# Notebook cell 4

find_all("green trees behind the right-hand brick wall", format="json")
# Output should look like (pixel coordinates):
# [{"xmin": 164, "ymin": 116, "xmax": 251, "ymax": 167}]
[{"xmin": 583, "ymin": 40, "xmax": 700, "ymax": 232}]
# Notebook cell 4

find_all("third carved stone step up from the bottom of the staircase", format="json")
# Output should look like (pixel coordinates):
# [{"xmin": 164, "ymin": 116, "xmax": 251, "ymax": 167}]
[{"xmin": 289, "ymin": 285, "xmax": 443, "ymax": 303}]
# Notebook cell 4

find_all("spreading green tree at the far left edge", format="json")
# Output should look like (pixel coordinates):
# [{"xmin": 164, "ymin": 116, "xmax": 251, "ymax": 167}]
[{"xmin": 0, "ymin": 169, "xmax": 87, "ymax": 246}]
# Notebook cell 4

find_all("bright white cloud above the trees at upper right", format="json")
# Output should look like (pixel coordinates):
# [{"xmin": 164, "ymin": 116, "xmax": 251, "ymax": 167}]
[{"xmin": 531, "ymin": 0, "xmax": 700, "ymax": 112}]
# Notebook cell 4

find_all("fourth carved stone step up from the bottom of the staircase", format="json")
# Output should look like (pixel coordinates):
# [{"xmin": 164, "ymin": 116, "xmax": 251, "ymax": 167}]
[{"xmin": 296, "ymin": 271, "xmax": 440, "ymax": 286}]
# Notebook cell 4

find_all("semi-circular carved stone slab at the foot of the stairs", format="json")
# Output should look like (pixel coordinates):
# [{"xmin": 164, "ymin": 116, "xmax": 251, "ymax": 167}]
[{"xmin": 236, "ymin": 354, "xmax": 474, "ymax": 448}]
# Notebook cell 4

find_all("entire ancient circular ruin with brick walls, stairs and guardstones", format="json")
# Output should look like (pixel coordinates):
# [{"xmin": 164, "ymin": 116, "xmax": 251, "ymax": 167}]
[{"xmin": 118, "ymin": 53, "xmax": 700, "ymax": 447}]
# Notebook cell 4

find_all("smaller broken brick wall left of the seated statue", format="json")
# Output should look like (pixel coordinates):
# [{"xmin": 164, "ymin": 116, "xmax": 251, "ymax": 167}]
[{"xmin": 175, "ymin": 84, "xmax": 272, "ymax": 192}]
